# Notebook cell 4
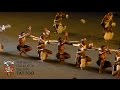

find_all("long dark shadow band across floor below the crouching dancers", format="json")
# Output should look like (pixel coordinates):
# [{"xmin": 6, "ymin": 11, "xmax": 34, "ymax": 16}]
[{"xmin": 0, "ymin": 52, "xmax": 112, "ymax": 74}]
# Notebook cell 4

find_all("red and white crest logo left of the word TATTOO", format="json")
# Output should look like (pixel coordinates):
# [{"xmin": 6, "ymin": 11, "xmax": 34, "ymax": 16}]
[{"xmin": 4, "ymin": 61, "xmax": 14, "ymax": 76}]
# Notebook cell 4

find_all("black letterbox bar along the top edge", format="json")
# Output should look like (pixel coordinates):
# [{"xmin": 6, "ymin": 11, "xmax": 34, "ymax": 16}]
[{"xmin": 0, "ymin": 0, "xmax": 120, "ymax": 11}]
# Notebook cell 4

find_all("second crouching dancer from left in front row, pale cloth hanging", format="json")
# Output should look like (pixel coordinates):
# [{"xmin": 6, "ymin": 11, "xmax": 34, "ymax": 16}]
[{"xmin": 37, "ymin": 34, "xmax": 52, "ymax": 62}]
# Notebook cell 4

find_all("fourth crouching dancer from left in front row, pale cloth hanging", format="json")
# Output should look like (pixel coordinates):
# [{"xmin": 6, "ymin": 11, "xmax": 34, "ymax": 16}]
[{"xmin": 76, "ymin": 38, "xmax": 91, "ymax": 69}]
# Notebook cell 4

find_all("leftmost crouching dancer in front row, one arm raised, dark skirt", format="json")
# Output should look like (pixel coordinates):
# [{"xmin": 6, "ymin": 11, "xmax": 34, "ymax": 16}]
[{"xmin": 17, "ymin": 28, "xmax": 32, "ymax": 56}]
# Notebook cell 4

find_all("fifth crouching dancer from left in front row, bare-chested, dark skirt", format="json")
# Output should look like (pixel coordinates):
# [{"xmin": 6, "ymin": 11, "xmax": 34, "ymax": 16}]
[{"xmin": 96, "ymin": 45, "xmax": 112, "ymax": 73}]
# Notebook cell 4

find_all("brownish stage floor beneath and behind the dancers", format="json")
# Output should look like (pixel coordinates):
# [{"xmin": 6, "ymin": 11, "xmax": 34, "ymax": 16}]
[{"xmin": 0, "ymin": 12, "xmax": 120, "ymax": 79}]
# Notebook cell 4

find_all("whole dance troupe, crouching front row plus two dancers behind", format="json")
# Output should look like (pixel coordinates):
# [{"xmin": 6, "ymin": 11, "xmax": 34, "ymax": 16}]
[{"xmin": 0, "ymin": 12, "xmax": 120, "ymax": 79}]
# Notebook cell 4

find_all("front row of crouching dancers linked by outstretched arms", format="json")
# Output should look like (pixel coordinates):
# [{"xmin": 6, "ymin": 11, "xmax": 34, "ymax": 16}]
[{"xmin": 17, "ymin": 25, "xmax": 120, "ymax": 78}]
